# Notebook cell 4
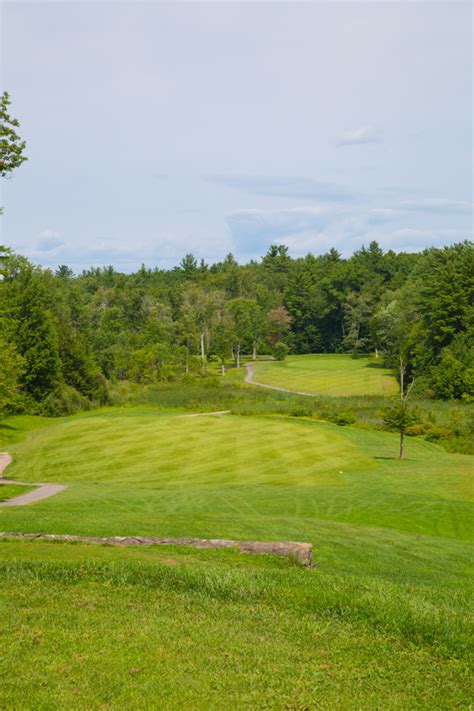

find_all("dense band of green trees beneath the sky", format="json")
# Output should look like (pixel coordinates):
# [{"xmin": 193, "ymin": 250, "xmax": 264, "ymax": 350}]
[{"xmin": 0, "ymin": 242, "xmax": 474, "ymax": 414}]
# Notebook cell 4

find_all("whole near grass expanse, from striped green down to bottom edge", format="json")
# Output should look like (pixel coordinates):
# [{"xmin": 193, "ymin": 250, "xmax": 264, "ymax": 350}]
[{"xmin": 0, "ymin": 406, "xmax": 473, "ymax": 709}]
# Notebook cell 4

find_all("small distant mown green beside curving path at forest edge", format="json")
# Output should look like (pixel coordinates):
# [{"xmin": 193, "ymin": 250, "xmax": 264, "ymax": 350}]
[{"xmin": 250, "ymin": 354, "xmax": 398, "ymax": 396}]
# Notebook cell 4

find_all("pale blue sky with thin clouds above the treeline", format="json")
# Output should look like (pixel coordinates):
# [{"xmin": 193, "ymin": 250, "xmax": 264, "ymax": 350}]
[{"xmin": 0, "ymin": 0, "xmax": 473, "ymax": 273}]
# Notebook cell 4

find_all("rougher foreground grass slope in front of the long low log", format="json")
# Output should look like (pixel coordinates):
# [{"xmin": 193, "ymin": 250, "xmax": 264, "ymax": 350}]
[{"xmin": 0, "ymin": 531, "xmax": 469, "ymax": 709}]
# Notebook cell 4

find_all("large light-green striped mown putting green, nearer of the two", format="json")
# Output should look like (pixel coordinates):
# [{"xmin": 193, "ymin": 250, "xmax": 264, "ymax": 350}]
[{"xmin": 9, "ymin": 410, "xmax": 375, "ymax": 488}]
